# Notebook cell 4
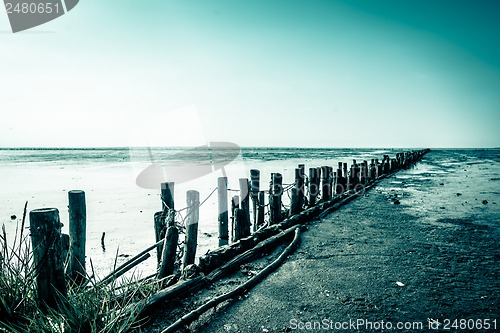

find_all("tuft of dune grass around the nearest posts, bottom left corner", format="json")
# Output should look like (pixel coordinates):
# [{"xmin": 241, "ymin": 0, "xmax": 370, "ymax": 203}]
[{"xmin": 0, "ymin": 203, "xmax": 158, "ymax": 333}]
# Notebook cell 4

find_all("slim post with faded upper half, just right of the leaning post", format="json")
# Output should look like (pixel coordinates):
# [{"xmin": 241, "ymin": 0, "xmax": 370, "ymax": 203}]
[{"xmin": 182, "ymin": 190, "xmax": 200, "ymax": 269}]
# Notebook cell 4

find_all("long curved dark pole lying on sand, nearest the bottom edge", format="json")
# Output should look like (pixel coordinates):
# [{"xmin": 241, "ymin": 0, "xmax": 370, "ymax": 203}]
[{"xmin": 161, "ymin": 228, "xmax": 300, "ymax": 333}]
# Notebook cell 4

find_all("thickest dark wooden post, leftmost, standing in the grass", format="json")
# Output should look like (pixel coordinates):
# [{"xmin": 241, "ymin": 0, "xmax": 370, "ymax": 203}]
[{"xmin": 30, "ymin": 208, "xmax": 67, "ymax": 309}]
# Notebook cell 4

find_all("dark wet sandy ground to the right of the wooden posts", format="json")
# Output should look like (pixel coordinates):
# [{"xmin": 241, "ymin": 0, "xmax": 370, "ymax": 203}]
[{"xmin": 142, "ymin": 151, "xmax": 500, "ymax": 333}]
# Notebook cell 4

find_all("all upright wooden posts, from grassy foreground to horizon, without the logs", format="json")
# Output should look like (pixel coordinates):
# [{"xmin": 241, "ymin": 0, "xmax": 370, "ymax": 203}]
[{"xmin": 26, "ymin": 150, "xmax": 428, "ymax": 307}]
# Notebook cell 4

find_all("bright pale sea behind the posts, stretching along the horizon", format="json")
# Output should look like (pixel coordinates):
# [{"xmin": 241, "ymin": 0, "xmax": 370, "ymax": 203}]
[{"xmin": 0, "ymin": 145, "xmax": 499, "ymax": 277}]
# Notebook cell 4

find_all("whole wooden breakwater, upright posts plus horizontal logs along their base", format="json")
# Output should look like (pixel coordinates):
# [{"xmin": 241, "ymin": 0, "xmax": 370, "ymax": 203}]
[{"xmin": 24, "ymin": 149, "xmax": 429, "ymax": 308}]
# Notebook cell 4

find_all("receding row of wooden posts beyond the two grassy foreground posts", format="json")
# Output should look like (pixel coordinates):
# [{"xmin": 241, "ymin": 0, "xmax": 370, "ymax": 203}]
[{"xmin": 155, "ymin": 150, "xmax": 427, "ymax": 278}]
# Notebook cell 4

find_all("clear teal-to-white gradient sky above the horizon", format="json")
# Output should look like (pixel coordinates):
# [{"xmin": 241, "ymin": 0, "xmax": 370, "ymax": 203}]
[{"xmin": 0, "ymin": 0, "xmax": 500, "ymax": 148}]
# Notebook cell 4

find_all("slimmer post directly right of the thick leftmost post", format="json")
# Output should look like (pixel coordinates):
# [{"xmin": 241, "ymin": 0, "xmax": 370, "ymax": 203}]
[{"xmin": 67, "ymin": 190, "xmax": 87, "ymax": 285}]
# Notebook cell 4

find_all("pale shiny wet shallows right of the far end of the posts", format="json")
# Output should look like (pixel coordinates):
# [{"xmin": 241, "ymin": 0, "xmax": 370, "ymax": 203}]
[{"xmin": 381, "ymin": 149, "xmax": 500, "ymax": 229}]
